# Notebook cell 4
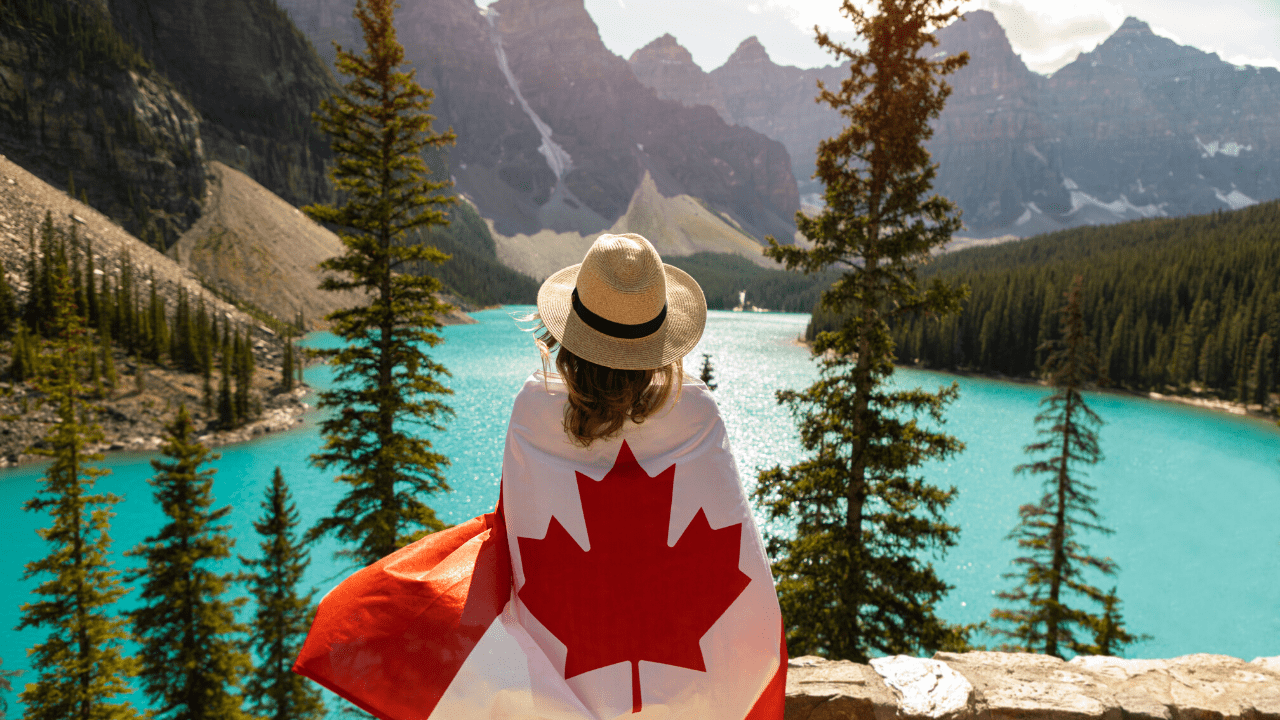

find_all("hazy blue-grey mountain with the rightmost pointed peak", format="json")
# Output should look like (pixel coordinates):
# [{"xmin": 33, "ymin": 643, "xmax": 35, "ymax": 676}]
[{"xmin": 1042, "ymin": 18, "xmax": 1280, "ymax": 224}]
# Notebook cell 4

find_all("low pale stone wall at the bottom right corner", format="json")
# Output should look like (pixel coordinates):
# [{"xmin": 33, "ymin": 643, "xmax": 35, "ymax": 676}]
[{"xmin": 786, "ymin": 652, "xmax": 1280, "ymax": 720}]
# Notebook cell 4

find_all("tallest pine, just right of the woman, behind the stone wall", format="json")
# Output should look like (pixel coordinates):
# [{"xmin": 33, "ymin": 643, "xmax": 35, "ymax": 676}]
[{"xmin": 755, "ymin": 0, "xmax": 968, "ymax": 662}]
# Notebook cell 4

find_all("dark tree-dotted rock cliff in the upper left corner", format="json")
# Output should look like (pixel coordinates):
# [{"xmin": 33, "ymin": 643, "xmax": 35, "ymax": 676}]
[{"xmin": 0, "ymin": 0, "xmax": 205, "ymax": 245}]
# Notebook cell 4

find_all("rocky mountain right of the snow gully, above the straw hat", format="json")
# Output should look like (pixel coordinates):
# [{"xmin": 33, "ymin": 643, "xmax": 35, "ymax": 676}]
[{"xmin": 483, "ymin": 0, "xmax": 800, "ymax": 237}]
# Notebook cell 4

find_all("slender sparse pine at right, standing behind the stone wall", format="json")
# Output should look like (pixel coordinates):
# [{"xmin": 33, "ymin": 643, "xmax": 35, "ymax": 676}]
[{"xmin": 991, "ymin": 275, "xmax": 1137, "ymax": 657}]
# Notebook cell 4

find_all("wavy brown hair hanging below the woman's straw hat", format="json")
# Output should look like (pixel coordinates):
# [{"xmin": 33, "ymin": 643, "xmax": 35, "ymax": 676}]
[{"xmin": 556, "ymin": 346, "xmax": 685, "ymax": 447}]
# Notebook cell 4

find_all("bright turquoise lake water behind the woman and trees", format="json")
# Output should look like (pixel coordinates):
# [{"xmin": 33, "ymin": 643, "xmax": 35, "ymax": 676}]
[{"xmin": 0, "ymin": 309, "xmax": 1280, "ymax": 715}]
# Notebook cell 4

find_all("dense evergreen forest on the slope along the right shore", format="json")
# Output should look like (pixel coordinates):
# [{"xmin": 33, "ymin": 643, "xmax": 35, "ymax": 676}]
[{"xmin": 806, "ymin": 202, "xmax": 1280, "ymax": 407}]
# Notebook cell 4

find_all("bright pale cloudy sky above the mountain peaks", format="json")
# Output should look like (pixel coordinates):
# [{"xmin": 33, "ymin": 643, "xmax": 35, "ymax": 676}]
[{"xmin": 573, "ymin": 0, "xmax": 1280, "ymax": 74}]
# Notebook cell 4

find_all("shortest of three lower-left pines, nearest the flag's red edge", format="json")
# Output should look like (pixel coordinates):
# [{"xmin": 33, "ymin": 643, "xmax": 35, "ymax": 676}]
[{"xmin": 241, "ymin": 466, "xmax": 324, "ymax": 720}]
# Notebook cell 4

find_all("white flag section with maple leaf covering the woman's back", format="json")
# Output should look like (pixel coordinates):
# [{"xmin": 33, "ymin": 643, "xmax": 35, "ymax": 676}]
[{"xmin": 477, "ymin": 373, "xmax": 782, "ymax": 720}]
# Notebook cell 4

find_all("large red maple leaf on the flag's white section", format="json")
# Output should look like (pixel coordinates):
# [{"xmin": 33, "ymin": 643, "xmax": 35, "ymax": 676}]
[{"xmin": 516, "ymin": 441, "xmax": 751, "ymax": 712}]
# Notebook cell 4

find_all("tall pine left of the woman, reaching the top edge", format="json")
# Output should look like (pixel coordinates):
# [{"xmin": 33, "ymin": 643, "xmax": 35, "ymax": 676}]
[{"xmin": 306, "ymin": 0, "xmax": 453, "ymax": 564}]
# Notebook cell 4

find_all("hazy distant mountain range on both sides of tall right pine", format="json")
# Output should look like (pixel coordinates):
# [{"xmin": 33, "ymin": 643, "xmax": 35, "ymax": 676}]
[{"xmin": 631, "ymin": 10, "xmax": 1280, "ymax": 237}]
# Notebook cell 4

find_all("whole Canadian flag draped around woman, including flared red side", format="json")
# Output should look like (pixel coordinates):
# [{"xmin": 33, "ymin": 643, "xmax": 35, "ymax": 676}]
[{"xmin": 293, "ymin": 373, "xmax": 786, "ymax": 720}]
